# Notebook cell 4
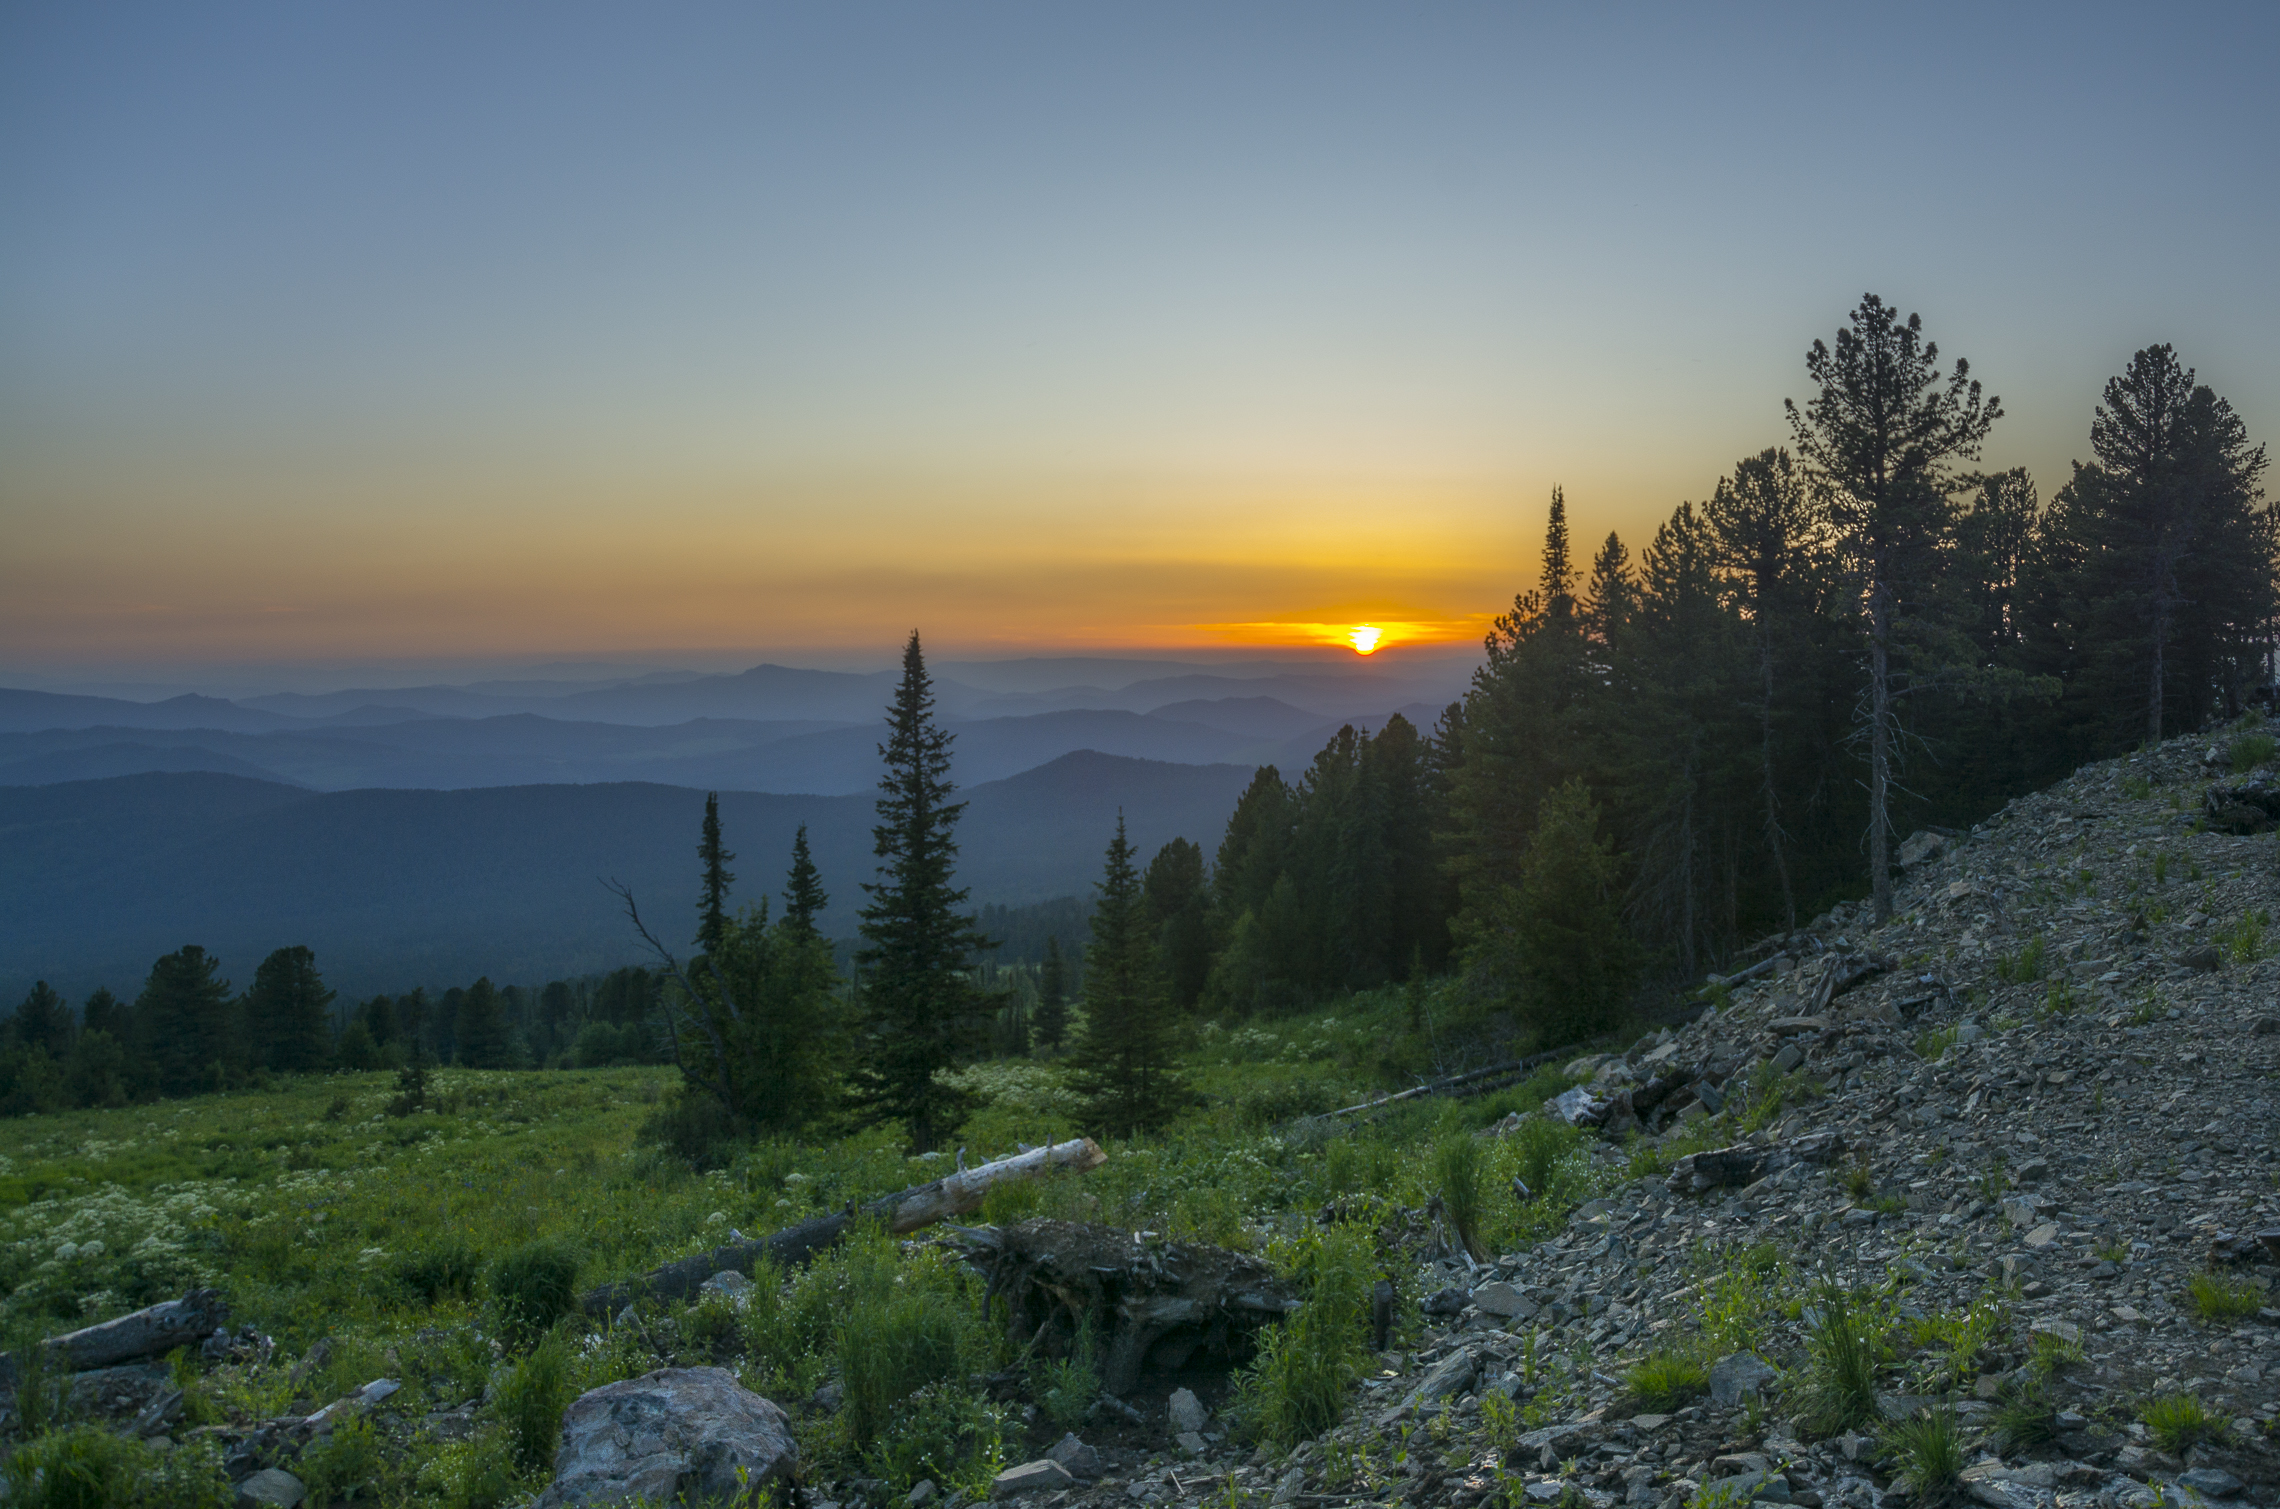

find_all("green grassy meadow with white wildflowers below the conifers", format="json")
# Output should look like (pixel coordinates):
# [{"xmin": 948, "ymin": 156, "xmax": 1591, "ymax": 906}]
[{"xmin": 0, "ymin": 992, "xmax": 1669, "ymax": 1509}]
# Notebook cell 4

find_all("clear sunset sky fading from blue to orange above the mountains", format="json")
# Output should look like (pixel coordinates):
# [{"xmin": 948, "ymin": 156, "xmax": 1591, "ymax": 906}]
[{"xmin": 0, "ymin": 0, "xmax": 2280, "ymax": 675}]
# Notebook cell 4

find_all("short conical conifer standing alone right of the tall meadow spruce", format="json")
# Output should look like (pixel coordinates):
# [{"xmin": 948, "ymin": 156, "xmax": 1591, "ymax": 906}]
[{"xmin": 1072, "ymin": 814, "xmax": 1181, "ymax": 1137}]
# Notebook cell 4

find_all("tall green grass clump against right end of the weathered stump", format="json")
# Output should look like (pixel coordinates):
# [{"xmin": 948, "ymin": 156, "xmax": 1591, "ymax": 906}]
[{"xmin": 1233, "ymin": 1226, "xmax": 1375, "ymax": 1447}]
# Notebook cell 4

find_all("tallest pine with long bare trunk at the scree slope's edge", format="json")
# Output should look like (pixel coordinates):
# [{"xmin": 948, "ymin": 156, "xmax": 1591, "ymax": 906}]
[{"xmin": 1785, "ymin": 294, "xmax": 2002, "ymax": 925}]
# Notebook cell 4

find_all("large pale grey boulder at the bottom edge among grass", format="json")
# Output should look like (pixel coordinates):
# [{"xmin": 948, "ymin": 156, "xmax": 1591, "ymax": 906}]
[{"xmin": 536, "ymin": 1368, "xmax": 800, "ymax": 1509}]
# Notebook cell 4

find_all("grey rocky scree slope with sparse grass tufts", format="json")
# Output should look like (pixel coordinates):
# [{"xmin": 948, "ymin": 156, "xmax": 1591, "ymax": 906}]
[{"xmin": 1030, "ymin": 741, "xmax": 2280, "ymax": 1509}]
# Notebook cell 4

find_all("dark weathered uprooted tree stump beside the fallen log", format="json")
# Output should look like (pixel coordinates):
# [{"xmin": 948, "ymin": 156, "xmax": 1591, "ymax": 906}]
[{"xmin": 958, "ymin": 1220, "xmax": 1297, "ymax": 1395}]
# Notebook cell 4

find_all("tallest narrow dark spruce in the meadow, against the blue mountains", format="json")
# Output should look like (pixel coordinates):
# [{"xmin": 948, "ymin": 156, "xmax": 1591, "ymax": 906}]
[{"xmin": 855, "ymin": 629, "xmax": 992, "ymax": 1153}]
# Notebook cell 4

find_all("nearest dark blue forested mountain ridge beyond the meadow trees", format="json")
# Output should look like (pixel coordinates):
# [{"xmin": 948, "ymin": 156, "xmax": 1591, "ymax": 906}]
[{"xmin": 0, "ymin": 745, "xmax": 1252, "ymax": 998}]
